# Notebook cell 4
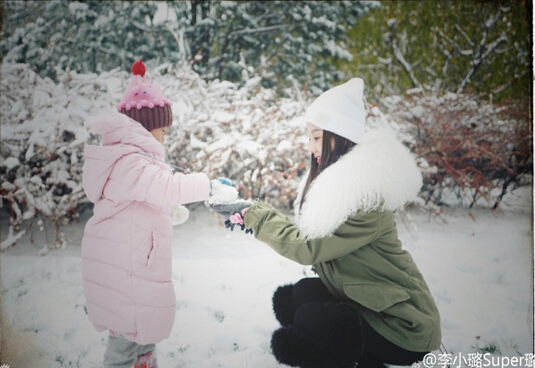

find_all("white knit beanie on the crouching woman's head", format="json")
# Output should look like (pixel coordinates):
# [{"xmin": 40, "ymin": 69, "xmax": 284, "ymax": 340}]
[{"xmin": 305, "ymin": 78, "xmax": 366, "ymax": 143}]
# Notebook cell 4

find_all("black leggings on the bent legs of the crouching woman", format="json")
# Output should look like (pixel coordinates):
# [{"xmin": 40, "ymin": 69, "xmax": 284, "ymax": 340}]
[{"xmin": 271, "ymin": 278, "xmax": 426, "ymax": 368}]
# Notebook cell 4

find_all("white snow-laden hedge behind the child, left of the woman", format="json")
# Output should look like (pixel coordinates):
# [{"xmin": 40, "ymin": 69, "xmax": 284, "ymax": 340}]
[{"xmin": 0, "ymin": 62, "xmax": 307, "ymax": 249}]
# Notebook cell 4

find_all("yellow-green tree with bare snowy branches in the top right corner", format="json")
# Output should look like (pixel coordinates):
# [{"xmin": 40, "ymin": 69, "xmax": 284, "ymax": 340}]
[{"xmin": 348, "ymin": 0, "xmax": 531, "ymax": 100}]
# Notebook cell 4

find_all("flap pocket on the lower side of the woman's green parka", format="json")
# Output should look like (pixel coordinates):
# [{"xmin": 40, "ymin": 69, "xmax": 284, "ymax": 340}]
[{"xmin": 344, "ymin": 283, "xmax": 410, "ymax": 312}]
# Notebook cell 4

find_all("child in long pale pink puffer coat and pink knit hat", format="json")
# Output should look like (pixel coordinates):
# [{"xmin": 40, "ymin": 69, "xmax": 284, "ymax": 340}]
[{"xmin": 82, "ymin": 61, "xmax": 237, "ymax": 368}]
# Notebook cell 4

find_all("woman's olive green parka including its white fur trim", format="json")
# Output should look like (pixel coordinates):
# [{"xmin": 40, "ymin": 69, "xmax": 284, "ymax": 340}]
[{"xmin": 244, "ymin": 131, "xmax": 441, "ymax": 352}]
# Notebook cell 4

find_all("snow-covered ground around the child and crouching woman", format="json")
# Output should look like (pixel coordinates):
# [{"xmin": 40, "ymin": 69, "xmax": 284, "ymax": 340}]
[{"xmin": 0, "ymin": 188, "xmax": 533, "ymax": 368}]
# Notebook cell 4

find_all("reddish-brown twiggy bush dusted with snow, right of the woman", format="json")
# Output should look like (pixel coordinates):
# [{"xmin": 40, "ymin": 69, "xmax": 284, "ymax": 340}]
[{"xmin": 382, "ymin": 91, "xmax": 533, "ymax": 208}]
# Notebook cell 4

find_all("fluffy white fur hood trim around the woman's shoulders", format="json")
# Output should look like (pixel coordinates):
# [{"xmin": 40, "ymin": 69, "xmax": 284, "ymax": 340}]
[{"xmin": 294, "ymin": 128, "xmax": 422, "ymax": 239}]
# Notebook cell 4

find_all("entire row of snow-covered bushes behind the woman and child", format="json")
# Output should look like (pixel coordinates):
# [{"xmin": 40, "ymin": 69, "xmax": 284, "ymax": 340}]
[{"xmin": 0, "ymin": 61, "xmax": 532, "ymax": 249}]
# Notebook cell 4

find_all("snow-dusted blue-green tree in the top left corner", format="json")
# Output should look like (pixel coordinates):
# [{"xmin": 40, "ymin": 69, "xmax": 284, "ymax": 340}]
[{"xmin": 0, "ymin": 0, "xmax": 176, "ymax": 80}]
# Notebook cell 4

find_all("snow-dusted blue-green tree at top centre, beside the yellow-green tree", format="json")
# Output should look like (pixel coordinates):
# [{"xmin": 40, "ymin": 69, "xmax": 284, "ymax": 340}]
[{"xmin": 165, "ymin": 1, "xmax": 376, "ymax": 94}]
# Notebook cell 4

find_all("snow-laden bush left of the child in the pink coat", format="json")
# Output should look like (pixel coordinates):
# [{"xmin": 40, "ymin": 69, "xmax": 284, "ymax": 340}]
[{"xmin": 0, "ymin": 63, "xmax": 116, "ymax": 248}]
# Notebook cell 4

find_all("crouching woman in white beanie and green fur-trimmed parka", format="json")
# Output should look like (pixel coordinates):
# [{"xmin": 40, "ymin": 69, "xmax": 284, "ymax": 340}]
[{"xmin": 212, "ymin": 78, "xmax": 441, "ymax": 368}]
